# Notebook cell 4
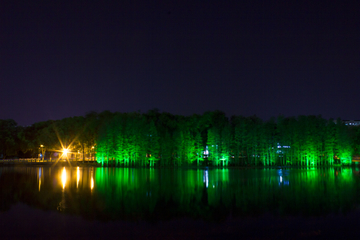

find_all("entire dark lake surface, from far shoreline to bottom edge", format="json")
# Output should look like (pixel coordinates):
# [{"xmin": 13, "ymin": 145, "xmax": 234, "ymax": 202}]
[{"xmin": 0, "ymin": 165, "xmax": 360, "ymax": 239}]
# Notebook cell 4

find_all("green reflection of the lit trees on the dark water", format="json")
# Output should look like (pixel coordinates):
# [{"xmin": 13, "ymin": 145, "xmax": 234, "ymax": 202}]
[{"xmin": 69, "ymin": 168, "xmax": 360, "ymax": 219}]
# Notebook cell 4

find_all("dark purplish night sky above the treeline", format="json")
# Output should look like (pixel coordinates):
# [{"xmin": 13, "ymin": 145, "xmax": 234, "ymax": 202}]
[{"xmin": 0, "ymin": 0, "xmax": 360, "ymax": 125}]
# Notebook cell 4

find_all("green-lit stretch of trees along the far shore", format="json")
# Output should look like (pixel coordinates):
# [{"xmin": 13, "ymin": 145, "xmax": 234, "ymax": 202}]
[{"xmin": 95, "ymin": 115, "xmax": 360, "ymax": 167}]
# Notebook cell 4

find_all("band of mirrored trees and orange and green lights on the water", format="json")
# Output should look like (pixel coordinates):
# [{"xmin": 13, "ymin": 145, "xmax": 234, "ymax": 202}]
[{"xmin": 0, "ymin": 167, "xmax": 360, "ymax": 221}]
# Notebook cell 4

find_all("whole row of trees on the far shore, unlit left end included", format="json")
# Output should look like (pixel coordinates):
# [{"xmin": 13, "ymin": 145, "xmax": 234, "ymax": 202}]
[{"xmin": 0, "ymin": 109, "xmax": 360, "ymax": 167}]
